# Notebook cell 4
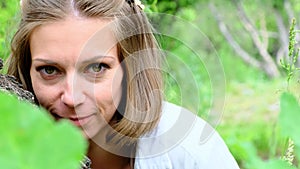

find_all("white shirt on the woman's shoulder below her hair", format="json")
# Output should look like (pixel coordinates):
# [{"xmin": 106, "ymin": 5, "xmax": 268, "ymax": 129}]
[{"xmin": 134, "ymin": 102, "xmax": 239, "ymax": 169}]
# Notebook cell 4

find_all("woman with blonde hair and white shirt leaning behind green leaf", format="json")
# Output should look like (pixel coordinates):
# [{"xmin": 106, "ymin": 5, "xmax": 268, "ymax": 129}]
[{"xmin": 8, "ymin": 0, "xmax": 238, "ymax": 169}]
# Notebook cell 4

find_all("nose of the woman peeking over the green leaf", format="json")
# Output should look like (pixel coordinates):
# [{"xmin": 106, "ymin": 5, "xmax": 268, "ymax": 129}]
[{"xmin": 61, "ymin": 73, "xmax": 85, "ymax": 108}]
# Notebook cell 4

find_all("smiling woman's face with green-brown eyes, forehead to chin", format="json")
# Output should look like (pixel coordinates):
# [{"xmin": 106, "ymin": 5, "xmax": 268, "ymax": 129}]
[{"xmin": 30, "ymin": 17, "xmax": 123, "ymax": 138}]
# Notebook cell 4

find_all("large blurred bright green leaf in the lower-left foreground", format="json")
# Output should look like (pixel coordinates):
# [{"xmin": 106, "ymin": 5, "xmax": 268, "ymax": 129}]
[{"xmin": 0, "ymin": 93, "xmax": 87, "ymax": 169}]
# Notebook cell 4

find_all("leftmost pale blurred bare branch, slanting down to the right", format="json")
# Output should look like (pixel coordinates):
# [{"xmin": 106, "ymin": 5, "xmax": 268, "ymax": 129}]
[{"xmin": 209, "ymin": 2, "xmax": 261, "ymax": 68}]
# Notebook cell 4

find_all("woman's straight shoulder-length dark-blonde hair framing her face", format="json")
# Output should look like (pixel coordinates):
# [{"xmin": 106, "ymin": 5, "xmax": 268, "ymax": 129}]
[{"xmin": 8, "ymin": 0, "xmax": 162, "ymax": 147}]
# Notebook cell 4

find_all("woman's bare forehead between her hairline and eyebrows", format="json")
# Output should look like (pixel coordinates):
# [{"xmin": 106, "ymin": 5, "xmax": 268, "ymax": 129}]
[{"xmin": 30, "ymin": 17, "xmax": 116, "ymax": 61}]
